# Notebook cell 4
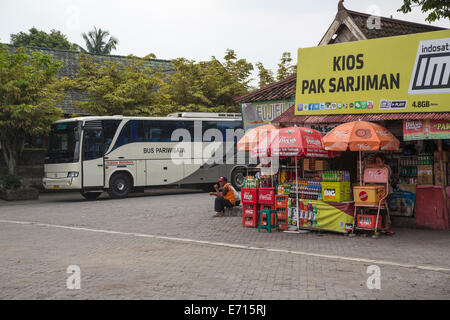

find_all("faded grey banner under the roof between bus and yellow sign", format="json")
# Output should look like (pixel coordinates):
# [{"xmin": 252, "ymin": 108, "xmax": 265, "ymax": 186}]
[{"xmin": 241, "ymin": 98, "xmax": 294, "ymax": 131}]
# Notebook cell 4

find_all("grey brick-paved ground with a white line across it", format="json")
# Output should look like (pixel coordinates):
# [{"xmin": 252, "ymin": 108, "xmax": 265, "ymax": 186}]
[{"xmin": 0, "ymin": 190, "xmax": 450, "ymax": 299}]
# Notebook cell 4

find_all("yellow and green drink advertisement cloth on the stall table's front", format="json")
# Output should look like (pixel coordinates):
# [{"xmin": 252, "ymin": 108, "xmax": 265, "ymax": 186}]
[{"xmin": 289, "ymin": 199, "xmax": 354, "ymax": 233}]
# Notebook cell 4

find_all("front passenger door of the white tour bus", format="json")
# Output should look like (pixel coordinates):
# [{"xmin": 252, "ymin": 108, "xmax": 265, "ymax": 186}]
[{"xmin": 82, "ymin": 121, "xmax": 105, "ymax": 188}]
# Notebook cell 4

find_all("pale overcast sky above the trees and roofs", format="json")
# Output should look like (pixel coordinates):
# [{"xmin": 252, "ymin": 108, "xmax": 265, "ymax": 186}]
[{"xmin": 0, "ymin": 0, "xmax": 450, "ymax": 82}]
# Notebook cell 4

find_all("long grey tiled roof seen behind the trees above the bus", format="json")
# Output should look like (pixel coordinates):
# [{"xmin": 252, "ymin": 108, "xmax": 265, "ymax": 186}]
[{"xmin": 8, "ymin": 45, "xmax": 173, "ymax": 115}]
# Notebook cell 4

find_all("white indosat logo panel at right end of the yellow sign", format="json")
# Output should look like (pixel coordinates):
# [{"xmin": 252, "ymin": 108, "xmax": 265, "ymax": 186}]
[{"xmin": 408, "ymin": 38, "xmax": 450, "ymax": 95}]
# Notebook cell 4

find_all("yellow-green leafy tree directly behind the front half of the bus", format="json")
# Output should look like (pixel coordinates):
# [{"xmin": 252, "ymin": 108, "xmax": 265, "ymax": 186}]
[{"xmin": 62, "ymin": 53, "xmax": 169, "ymax": 116}]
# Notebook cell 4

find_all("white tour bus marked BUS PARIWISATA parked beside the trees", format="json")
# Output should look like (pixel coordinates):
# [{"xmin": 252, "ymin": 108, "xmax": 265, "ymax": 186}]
[{"xmin": 43, "ymin": 113, "xmax": 245, "ymax": 200}]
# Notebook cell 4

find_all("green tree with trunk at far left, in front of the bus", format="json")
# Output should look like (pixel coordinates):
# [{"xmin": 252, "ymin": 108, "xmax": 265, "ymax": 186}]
[{"xmin": 0, "ymin": 45, "xmax": 62, "ymax": 175}]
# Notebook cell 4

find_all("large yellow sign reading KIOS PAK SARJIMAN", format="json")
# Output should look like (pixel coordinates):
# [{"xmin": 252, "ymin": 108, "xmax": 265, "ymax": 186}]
[{"xmin": 295, "ymin": 30, "xmax": 450, "ymax": 115}]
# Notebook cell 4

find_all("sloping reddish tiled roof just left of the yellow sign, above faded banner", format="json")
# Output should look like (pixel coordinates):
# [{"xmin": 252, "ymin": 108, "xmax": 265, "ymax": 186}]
[{"xmin": 234, "ymin": 75, "xmax": 297, "ymax": 103}]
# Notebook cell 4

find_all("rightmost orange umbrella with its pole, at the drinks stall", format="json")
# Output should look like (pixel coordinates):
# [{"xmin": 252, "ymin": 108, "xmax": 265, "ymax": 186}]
[{"xmin": 322, "ymin": 121, "xmax": 400, "ymax": 184}]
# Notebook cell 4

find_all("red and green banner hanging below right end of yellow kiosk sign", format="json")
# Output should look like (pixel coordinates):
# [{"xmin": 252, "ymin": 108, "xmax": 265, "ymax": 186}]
[{"xmin": 403, "ymin": 120, "xmax": 450, "ymax": 141}]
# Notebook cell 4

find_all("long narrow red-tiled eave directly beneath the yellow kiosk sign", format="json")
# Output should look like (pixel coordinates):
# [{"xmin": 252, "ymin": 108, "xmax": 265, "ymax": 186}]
[{"xmin": 272, "ymin": 106, "xmax": 450, "ymax": 125}]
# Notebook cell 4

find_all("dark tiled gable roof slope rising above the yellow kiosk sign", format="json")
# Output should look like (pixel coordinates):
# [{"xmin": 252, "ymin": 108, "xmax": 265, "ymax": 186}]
[{"xmin": 345, "ymin": 9, "xmax": 445, "ymax": 39}]
